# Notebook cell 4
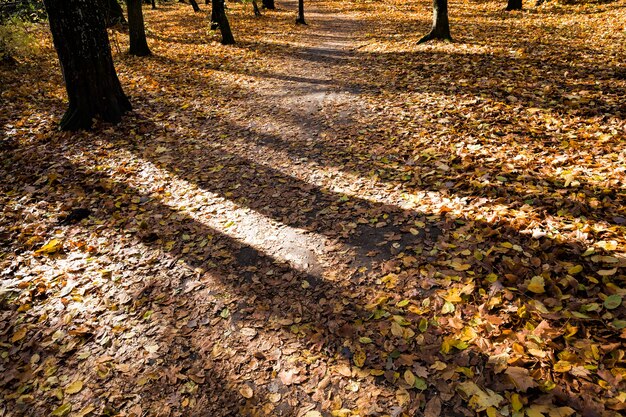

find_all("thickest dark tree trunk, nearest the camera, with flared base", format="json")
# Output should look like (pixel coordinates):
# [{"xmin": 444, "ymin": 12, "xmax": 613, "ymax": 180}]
[{"xmin": 44, "ymin": 0, "xmax": 131, "ymax": 130}]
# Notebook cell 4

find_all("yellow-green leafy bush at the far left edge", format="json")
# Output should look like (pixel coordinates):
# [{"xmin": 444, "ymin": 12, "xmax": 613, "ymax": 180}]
[{"xmin": 0, "ymin": 16, "xmax": 38, "ymax": 61}]
